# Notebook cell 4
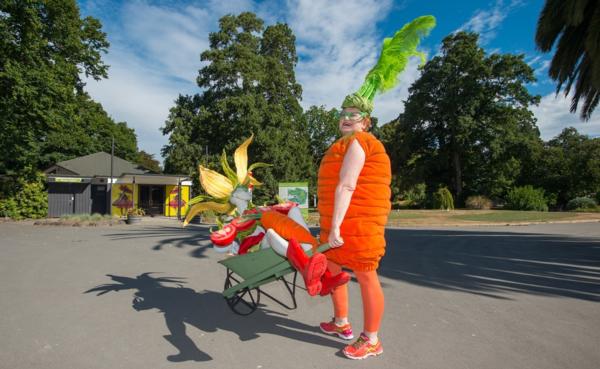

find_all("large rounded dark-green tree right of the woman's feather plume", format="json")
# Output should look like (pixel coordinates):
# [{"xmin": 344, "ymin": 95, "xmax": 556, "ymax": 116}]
[{"xmin": 384, "ymin": 32, "xmax": 539, "ymax": 203}]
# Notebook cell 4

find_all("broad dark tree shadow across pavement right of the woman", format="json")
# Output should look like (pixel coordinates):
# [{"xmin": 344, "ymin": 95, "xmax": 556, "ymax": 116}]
[{"xmin": 379, "ymin": 229, "xmax": 600, "ymax": 301}]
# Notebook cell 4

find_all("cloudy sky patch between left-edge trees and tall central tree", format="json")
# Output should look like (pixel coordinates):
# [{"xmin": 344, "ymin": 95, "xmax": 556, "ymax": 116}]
[{"xmin": 82, "ymin": 0, "xmax": 252, "ymax": 161}]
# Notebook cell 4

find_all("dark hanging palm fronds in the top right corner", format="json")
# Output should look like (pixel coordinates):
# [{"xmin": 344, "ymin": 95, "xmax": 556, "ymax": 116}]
[{"xmin": 535, "ymin": 0, "xmax": 600, "ymax": 120}]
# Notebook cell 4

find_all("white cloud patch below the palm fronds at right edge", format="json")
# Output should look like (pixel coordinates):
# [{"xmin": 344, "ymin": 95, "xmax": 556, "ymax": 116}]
[{"xmin": 531, "ymin": 93, "xmax": 600, "ymax": 141}]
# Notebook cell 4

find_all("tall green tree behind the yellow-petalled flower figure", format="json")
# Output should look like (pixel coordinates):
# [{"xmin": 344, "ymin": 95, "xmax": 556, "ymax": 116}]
[{"xmin": 163, "ymin": 12, "xmax": 312, "ymax": 202}]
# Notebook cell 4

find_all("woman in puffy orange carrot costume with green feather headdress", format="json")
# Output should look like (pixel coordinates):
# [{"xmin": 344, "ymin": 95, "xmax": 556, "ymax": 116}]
[{"xmin": 317, "ymin": 16, "xmax": 435, "ymax": 359}]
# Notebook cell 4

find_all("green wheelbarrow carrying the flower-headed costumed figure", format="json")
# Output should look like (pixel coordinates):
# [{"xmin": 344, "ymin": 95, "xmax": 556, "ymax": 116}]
[{"xmin": 219, "ymin": 243, "xmax": 329, "ymax": 315}]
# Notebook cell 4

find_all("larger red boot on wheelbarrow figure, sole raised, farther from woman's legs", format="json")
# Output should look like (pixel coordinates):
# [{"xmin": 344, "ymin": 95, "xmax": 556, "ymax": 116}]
[{"xmin": 286, "ymin": 238, "xmax": 327, "ymax": 296}]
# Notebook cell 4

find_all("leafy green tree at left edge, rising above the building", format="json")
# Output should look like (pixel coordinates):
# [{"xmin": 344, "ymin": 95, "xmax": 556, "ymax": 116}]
[{"xmin": 0, "ymin": 0, "xmax": 108, "ymax": 174}]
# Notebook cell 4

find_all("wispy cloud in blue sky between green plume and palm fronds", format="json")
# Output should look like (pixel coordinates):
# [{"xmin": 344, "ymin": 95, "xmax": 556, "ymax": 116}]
[{"xmin": 455, "ymin": 0, "xmax": 523, "ymax": 45}]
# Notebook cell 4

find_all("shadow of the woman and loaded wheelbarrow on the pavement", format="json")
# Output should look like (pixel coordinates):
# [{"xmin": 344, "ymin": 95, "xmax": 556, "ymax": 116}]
[{"xmin": 85, "ymin": 273, "xmax": 340, "ymax": 362}]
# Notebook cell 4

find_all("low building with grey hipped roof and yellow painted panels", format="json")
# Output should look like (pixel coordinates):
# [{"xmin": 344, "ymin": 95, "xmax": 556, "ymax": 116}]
[{"xmin": 44, "ymin": 152, "xmax": 192, "ymax": 217}]
